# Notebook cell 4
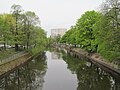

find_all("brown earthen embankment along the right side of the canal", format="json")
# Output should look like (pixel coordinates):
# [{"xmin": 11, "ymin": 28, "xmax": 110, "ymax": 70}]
[{"xmin": 54, "ymin": 45, "xmax": 120, "ymax": 76}]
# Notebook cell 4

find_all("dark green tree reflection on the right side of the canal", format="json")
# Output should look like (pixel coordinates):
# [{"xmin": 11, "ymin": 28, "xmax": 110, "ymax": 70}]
[{"xmin": 62, "ymin": 51, "xmax": 120, "ymax": 90}]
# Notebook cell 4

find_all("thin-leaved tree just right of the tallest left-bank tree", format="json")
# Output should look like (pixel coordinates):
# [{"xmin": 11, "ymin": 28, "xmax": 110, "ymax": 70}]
[{"xmin": 25, "ymin": 11, "xmax": 40, "ymax": 49}]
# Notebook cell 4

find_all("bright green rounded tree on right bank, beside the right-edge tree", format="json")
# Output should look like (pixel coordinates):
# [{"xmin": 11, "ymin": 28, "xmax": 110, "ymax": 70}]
[{"xmin": 76, "ymin": 11, "xmax": 100, "ymax": 52}]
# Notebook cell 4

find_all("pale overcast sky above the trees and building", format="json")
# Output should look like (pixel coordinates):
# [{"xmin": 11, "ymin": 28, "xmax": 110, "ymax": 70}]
[{"xmin": 0, "ymin": 0, "xmax": 103, "ymax": 35}]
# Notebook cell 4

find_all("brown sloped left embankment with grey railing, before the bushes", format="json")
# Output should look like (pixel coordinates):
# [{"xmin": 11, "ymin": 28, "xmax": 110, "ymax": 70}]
[{"xmin": 0, "ymin": 52, "xmax": 33, "ymax": 77}]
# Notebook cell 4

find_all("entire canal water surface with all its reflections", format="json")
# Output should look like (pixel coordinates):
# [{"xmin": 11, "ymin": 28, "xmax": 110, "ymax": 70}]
[{"xmin": 0, "ymin": 50, "xmax": 120, "ymax": 90}]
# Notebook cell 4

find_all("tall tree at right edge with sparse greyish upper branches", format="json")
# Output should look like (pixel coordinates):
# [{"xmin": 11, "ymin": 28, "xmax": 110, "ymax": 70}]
[{"xmin": 94, "ymin": 0, "xmax": 120, "ymax": 61}]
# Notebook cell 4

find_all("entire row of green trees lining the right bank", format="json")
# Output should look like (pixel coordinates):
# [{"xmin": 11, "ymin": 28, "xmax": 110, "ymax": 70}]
[{"xmin": 59, "ymin": 0, "xmax": 120, "ymax": 61}]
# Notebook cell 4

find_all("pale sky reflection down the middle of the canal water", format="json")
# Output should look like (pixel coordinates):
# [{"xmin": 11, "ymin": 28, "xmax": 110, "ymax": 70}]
[{"xmin": 43, "ymin": 51, "xmax": 77, "ymax": 90}]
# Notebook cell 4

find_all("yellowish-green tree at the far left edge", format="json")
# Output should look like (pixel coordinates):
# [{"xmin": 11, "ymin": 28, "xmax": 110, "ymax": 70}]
[{"xmin": 0, "ymin": 14, "xmax": 15, "ymax": 49}]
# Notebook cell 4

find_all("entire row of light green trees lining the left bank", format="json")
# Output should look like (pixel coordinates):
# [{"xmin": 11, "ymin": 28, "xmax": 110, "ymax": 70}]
[{"xmin": 0, "ymin": 4, "xmax": 47, "ymax": 51}]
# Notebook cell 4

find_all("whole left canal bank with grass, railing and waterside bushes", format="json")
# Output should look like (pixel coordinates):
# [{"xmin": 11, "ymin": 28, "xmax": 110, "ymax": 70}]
[{"xmin": 0, "ymin": 47, "xmax": 44, "ymax": 78}]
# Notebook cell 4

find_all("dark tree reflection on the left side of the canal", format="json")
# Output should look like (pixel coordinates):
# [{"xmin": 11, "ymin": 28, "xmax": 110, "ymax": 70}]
[{"xmin": 0, "ymin": 53, "xmax": 47, "ymax": 90}]
